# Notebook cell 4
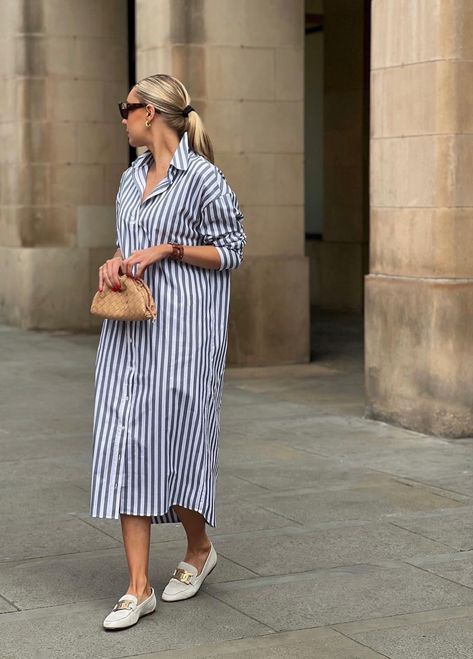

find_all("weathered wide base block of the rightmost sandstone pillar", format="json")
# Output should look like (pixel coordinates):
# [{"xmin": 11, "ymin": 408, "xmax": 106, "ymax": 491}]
[{"xmin": 365, "ymin": 275, "xmax": 473, "ymax": 438}]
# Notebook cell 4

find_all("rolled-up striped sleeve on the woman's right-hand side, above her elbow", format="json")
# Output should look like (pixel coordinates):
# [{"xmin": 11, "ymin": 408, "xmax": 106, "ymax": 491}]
[{"xmin": 200, "ymin": 191, "xmax": 246, "ymax": 270}]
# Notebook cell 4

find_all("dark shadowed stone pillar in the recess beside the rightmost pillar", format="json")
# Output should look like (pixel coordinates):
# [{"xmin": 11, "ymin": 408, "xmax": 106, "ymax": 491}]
[{"xmin": 307, "ymin": 0, "xmax": 370, "ymax": 312}]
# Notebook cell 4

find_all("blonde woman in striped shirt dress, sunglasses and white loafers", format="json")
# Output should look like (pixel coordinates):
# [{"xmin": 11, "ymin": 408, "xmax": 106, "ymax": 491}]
[{"xmin": 90, "ymin": 75, "xmax": 246, "ymax": 629}]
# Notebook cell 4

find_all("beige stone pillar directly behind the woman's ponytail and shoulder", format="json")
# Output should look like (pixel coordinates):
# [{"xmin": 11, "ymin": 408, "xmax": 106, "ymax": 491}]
[{"xmin": 136, "ymin": 0, "xmax": 309, "ymax": 365}]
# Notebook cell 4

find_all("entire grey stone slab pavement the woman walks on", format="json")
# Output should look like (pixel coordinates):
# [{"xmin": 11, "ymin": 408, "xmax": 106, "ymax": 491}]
[{"xmin": 0, "ymin": 314, "xmax": 473, "ymax": 659}]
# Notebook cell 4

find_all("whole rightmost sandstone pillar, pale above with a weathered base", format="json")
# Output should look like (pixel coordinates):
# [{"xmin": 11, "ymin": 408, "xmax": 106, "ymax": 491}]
[{"xmin": 365, "ymin": 0, "xmax": 473, "ymax": 437}]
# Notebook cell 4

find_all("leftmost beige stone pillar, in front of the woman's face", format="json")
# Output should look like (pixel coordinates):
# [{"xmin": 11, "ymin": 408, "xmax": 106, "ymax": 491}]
[{"xmin": 0, "ymin": 0, "xmax": 128, "ymax": 329}]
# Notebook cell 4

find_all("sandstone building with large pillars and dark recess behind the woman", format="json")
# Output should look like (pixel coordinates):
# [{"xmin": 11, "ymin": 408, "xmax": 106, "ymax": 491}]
[{"xmin": 0, "ymin": 0, "xmax": 473, "ymax": 436}]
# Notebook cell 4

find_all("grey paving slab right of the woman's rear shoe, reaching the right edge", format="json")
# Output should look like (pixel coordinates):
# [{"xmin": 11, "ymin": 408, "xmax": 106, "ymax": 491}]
[{"xmin": 206, "ymin": 564, "xmax": 473, "ymax": 631}]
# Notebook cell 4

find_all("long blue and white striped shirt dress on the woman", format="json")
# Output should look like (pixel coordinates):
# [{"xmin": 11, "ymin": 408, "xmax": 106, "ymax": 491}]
[{"xmin": 89, "ymin": 132, "xmax": 246, "ymax": 526}]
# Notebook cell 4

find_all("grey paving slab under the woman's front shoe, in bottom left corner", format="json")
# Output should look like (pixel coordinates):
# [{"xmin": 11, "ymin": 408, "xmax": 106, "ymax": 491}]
[{"xmin": 0, "ymin": 593, "xmax": 272, "ymax": 659}]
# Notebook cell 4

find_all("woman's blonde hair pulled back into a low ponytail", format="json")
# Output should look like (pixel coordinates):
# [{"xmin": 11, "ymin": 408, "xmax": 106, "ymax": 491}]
[{"xmin": 134, "ymin": 73, "xmax": 214, "ymax": 163}]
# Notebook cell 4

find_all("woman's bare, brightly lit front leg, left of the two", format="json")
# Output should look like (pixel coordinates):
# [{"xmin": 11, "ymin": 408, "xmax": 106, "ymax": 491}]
[{"xmin": 120, "ymin": 513, "xmax": 151, "ymax": 602}]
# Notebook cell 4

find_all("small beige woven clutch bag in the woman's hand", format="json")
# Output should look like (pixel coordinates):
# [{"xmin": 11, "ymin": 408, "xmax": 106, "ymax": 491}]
[{"xmin": 90, "ymin": 275, "xmax": 157, "ymax": 320}]
